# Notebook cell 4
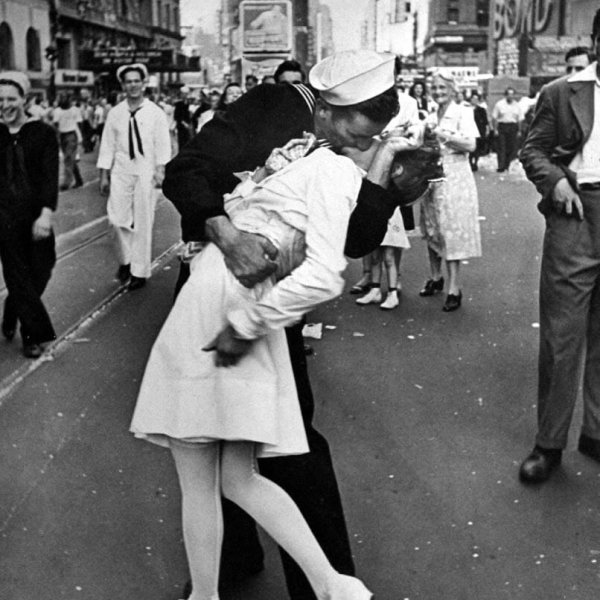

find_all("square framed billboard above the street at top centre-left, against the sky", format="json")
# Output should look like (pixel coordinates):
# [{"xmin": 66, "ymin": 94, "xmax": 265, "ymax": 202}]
[{"xmin": 240, "ymin": 0, "xmax": 292, "ymax": 54}]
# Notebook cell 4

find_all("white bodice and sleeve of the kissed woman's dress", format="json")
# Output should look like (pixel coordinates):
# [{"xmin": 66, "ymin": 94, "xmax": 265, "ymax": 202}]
[{"xmin": 225, "ymin": 148, "xmax": 362, "ymax": 339}]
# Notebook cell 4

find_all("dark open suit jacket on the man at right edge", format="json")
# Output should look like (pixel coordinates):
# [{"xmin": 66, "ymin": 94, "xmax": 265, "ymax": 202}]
[{"xmin": 520, "ymin": 70, "xmax": 595, "ymax": 214}]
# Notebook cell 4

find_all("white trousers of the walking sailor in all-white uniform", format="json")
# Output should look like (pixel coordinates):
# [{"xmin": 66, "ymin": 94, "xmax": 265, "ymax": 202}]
[{"xmin": 107, "ymin": 172, "xmax": 157, "ymax": 278}]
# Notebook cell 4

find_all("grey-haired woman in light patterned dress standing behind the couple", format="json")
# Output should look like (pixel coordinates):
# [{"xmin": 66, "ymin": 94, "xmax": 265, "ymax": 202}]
[{"xmin": 419, "ymin": 72, "xmax": 481, "ymax": 312}]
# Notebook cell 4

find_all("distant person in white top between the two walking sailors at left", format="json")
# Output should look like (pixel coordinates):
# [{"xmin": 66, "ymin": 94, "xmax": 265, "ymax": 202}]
[{"xmin": 52, "ymin": 96, "xmax": 83, "ymax": 190}]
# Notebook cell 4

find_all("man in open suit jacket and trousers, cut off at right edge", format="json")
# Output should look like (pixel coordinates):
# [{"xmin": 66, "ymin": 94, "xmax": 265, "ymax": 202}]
[{"xmin": 519, "ymin": 10, "xmax": 600, "ymax": 483}]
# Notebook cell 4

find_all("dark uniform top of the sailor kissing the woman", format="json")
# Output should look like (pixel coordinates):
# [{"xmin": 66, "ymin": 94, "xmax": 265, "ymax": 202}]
[{"xmin": 163, "ymin": 84, "xmax": 398, "ymax": 258}]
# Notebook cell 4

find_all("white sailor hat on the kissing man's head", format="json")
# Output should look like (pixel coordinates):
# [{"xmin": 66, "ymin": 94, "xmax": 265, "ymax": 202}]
[{"xmin": 308, "ymin": 50, "xmax": 396, "ymax": 106}]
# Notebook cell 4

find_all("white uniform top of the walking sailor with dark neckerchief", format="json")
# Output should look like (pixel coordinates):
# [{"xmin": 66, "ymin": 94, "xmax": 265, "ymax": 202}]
[{"xmin": 96, "ymin": 98, "xmax": 171, "ymax": 175}]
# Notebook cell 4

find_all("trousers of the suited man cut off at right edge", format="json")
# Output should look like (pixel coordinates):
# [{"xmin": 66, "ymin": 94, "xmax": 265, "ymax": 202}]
[{"xmin": 536, "ymin": 190, "xmax": 600, "ymax": 448}]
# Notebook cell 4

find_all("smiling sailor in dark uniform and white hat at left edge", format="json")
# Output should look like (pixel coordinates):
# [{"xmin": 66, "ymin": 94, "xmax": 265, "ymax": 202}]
[{"xmin": 0, "ymin": 71, "xmax": 58, "ymax": 358}]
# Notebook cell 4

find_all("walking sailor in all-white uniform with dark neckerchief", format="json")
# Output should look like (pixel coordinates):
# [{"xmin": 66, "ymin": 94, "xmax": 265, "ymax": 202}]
[{"xmin": 97, "ymin": 63, "xmax": 171, "ymax": 290}]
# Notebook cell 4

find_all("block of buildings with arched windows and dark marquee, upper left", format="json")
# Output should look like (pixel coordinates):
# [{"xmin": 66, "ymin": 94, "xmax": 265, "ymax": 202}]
[{"xmin": 0, "ymin": 0, "xmax": 186, "ymax": 96}]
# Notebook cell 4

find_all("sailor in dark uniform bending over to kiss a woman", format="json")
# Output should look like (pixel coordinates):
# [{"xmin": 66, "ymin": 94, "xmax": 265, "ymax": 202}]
[{"xmin": 163, "ymin": 51, "xmax": 412, "ymax": 600}]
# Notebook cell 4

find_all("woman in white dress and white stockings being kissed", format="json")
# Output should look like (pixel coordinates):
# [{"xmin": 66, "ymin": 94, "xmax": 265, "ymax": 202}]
[{"xmin": 131, "ymin": 137, "xmax": 372, "ymax": 600}]
